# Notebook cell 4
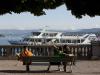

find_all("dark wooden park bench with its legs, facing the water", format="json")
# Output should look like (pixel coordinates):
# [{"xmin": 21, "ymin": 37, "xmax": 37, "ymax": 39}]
[{"xmin": 23, "ymin": 55, "xmax": 75, "ymax": 72}]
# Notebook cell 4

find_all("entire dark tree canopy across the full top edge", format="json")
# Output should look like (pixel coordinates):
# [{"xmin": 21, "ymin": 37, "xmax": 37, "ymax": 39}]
[{"xmin": 0, "ymin": 0, "xmax": 100, "ymax": 18}]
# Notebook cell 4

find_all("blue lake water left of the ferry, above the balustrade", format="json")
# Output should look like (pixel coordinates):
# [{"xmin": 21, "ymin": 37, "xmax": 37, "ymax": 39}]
[{"xmin": 0, "ymin": 30, "xmax": 32, "ymax": 45}]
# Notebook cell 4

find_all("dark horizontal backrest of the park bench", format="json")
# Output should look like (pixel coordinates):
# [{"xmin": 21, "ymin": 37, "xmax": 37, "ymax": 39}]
[{"xmin": 23, "ymin": 56, "xmax": 74, "ymax": 62}]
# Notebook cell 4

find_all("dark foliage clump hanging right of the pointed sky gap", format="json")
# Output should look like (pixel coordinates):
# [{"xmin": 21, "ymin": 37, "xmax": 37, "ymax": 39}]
[{"xmin": 65, "ymin": 0, "xmax": 100, "ymax": 18}]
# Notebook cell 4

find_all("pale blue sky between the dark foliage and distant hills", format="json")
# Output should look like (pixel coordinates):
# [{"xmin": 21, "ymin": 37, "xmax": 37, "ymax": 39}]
[{"xmin": 0, "ymin": 5, "xmax": 100, "ymax": 30}]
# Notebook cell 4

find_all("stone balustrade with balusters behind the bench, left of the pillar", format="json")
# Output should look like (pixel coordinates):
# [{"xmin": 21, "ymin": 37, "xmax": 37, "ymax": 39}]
[{"xmin": 0, "ymin": 45, "xmax": 93, "ymax": 60}]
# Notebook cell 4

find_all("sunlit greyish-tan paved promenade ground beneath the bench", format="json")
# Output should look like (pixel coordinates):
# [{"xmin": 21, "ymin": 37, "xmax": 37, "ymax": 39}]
[{"xmin": 0, "ymin": 60, "xmax": 100, "ymax": 75}]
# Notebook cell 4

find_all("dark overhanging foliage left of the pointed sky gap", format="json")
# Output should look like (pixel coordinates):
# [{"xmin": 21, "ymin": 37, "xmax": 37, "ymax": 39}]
[{"xmin": 0, "ymin": 0, "xmax": 63, "ymax": 16}]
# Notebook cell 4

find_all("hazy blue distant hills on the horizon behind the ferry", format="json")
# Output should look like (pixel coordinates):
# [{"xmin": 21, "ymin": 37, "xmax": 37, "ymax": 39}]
[{"xmin": 0, "ymin": 28, "xmax": 100, "ymax": 36}]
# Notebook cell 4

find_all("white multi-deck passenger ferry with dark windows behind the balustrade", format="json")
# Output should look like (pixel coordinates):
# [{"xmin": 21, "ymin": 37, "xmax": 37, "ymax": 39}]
[{"xmin": 9, "ymin": 30, "xmax": 97, "ymax": 45}]
